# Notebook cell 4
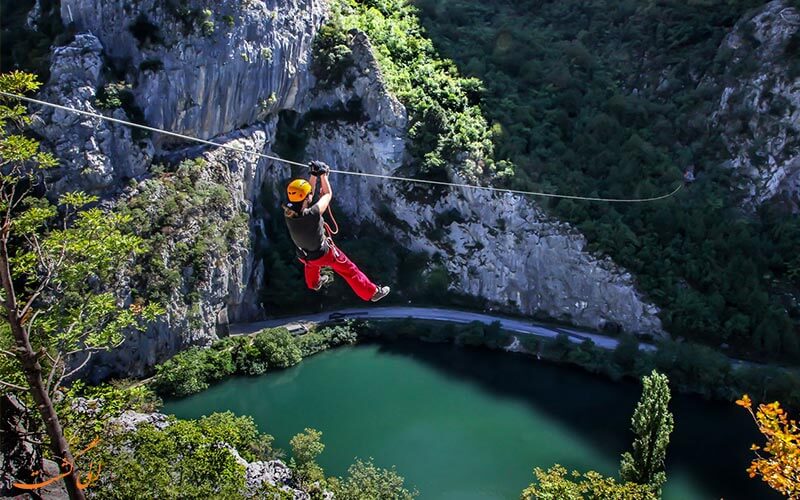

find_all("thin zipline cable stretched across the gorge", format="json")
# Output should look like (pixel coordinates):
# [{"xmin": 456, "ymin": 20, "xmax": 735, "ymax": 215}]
[{"xmin": 0, "ymin": 91, "xmax": 683, "ymax": 203}]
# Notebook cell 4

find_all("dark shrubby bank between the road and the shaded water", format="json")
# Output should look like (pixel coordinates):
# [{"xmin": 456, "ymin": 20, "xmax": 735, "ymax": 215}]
[{"xmin": 356, "ymin": 318, "xmax": 800, "ymax": 408}]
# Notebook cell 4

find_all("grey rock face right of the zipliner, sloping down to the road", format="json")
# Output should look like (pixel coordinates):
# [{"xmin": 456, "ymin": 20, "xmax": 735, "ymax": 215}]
[{"xmin": 306, "ymin": 31, "xmax": 662, "ymax": 333}]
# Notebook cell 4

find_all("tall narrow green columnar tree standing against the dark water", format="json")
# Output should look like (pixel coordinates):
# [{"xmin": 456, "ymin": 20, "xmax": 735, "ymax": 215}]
[{"xmin": 619, "ymin": 370, "xmax": 674, "ymax": 497}]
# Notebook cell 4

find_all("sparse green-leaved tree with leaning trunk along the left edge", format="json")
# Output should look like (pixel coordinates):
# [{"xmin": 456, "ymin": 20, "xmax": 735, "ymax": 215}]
[{"xmin": 0, "ymin": 72, "xmax": 159, "ymax": 499}]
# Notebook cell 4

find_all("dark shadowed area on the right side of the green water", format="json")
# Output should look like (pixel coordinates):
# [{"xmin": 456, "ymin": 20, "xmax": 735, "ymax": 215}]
[{"xmin": 374, "ymin": 339, "xmax": 780, "ymax": 499}]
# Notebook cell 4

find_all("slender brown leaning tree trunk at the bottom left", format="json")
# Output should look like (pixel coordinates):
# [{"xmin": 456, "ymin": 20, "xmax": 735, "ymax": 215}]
[{"xmin": 0, "ymin": 254, "xmax": 86, "ymax": 500}]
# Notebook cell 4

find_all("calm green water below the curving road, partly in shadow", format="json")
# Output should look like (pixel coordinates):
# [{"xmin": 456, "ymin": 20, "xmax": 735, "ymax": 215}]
[{"xmin": 164, "ymin": 342, "xmax": 772, "ymax": 500}]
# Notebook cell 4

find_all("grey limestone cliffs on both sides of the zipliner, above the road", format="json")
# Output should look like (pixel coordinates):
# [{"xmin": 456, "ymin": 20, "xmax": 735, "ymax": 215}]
[{"xmin": 28, "ymin": 0, "xmax": 662, "ymax": 379}]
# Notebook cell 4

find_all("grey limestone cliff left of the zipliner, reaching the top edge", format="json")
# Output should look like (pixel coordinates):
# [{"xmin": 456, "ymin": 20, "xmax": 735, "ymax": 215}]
[{"xmin": 34, "ymin": 0, "xmax": 325, "ymax": 381}]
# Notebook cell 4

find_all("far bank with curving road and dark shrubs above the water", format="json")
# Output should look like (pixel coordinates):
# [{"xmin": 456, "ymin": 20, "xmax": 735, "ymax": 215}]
[{"xmin": 232, "ymin": 306, "xmax": 800, "ymax": 408}]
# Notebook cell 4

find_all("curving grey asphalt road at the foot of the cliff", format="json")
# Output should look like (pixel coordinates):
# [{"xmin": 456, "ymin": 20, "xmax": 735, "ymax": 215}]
[{"xmin": 231, "ymin": 307, "xmax": 655, "ymax": 350}]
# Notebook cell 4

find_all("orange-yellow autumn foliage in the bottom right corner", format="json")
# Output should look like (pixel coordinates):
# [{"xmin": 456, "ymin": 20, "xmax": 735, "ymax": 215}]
[{"xmin": 736, "ymin": 394, "xmax": 800, "ymax": 498}]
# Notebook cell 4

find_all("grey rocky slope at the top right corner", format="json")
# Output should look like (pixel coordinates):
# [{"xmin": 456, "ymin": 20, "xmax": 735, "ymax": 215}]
[{"xmin": 711, "ymin": 0, "xmax": 800, "ymax": 211}]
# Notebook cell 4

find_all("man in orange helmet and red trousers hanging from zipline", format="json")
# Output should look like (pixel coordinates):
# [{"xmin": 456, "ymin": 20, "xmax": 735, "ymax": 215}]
[{"xmin": 283, "ymin": 161, "xmax": 389, "ymax": 302}]
